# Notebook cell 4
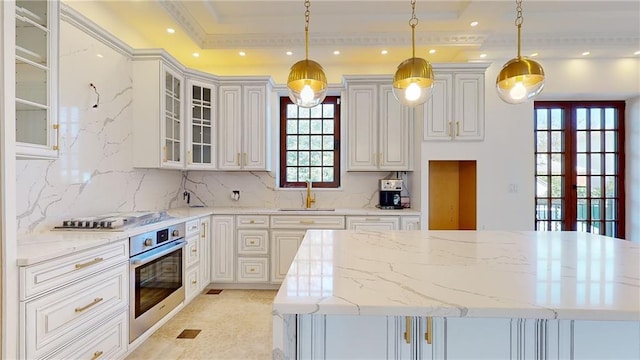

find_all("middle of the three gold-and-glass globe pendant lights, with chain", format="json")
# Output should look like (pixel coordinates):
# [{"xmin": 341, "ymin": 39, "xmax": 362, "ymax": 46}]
[{"xmin": 393, "ymin": 0, "xmax": 434, "ymax": 107}]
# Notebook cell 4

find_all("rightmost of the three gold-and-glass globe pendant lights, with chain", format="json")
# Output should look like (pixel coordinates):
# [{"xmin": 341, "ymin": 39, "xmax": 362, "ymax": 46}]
[{"xmin": 496, "ymin": 0, "xmax": 544, "ymax": 104}]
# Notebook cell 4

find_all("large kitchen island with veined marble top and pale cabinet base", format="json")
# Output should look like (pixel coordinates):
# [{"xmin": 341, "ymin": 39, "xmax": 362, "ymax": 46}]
[{"xmin": 273, "ymin": 230, "xmax": 640, "ymax": 359}]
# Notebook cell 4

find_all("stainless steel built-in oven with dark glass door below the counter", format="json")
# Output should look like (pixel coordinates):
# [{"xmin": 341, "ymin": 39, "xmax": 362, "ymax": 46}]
[{"xmin": 129, "ymin": 223, "xmax": 187, "ymax": 342}]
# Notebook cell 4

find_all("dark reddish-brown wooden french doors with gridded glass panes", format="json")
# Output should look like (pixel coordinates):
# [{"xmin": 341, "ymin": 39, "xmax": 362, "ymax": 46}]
[{"xmin": 534, "ymin": 101, "xmax": 624, "ymax": 238}]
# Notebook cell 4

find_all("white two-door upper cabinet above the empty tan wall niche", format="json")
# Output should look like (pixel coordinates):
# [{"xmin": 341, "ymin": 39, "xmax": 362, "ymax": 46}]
[{"xmin": 417, "ymin": 64, "xmax": 487, "ymax": 140}]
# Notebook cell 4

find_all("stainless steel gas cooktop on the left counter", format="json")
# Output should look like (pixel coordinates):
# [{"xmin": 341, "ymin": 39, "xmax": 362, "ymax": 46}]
[{"xmin": 55, "ymin": 211, "xmax": 172, "ymax": 231}]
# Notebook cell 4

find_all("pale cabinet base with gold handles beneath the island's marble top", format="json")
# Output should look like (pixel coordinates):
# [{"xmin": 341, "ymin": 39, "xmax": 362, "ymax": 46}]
[{"xmin": 295, "ymin": 314, "xmax": 640, "ymax": 360}]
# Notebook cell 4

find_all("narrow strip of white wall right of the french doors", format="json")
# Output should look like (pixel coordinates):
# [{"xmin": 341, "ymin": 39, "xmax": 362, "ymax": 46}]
[{"xmin": 625, "ymin": 97, "xmax": 640, "ymax": 242}]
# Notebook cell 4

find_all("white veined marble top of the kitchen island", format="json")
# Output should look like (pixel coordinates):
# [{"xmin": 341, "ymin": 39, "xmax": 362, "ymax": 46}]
[{"xmin": 273, "ymin": 230, "xmax": 640, "ymax": 320}]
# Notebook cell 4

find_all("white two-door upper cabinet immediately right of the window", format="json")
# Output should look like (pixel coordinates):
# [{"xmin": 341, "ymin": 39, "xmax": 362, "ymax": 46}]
[{"xmin": 344, "ymin": 76, "xmax": 413, "ymax": 171}]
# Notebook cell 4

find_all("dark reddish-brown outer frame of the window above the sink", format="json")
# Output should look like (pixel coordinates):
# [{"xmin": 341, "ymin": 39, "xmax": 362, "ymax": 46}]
[{"xmin": 278, "ymin": 96, "xmax": 341, "ymax": 189}]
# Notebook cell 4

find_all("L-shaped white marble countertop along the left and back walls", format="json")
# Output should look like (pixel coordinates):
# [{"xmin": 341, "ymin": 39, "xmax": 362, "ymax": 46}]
[{"xmin": 17, "ymin": 207, "xmax": 420, "ymax": 266}]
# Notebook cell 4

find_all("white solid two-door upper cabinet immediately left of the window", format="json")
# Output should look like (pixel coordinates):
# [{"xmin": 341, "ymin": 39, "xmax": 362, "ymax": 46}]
[{"xmin": 218, "ymin": 78, "xmax": 272, "ymax": 171}]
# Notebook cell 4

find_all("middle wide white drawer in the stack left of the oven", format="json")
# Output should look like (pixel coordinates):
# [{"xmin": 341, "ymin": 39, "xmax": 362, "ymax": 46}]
[{"xmin": 21, "ymin": 263, "xmax": 129, "ymax": 359}]
